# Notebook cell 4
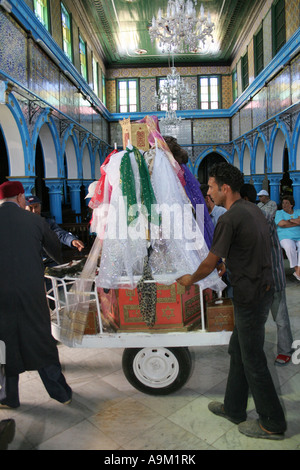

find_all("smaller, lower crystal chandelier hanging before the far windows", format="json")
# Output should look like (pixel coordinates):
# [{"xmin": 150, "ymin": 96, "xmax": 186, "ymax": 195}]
[{"xmin": 155, "ymin": 63, "xmax": 195, "ymax": 126}]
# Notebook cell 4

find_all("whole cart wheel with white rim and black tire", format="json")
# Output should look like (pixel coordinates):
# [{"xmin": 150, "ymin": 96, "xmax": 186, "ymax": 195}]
[{"xmin": 122, "ymin": 347, "xmax": 192, "ymax": 395}]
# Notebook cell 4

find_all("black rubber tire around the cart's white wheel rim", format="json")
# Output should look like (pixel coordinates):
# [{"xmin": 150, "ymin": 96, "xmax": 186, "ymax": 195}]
[{"xmin": 122, "ymin": 347, "xmax": 192, "ymax": 395}]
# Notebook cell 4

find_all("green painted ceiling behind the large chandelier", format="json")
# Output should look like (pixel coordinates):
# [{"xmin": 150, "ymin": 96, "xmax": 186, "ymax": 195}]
[{"xmin": 82, "ymin": 0, "xmax": 264, "ymax": 67}]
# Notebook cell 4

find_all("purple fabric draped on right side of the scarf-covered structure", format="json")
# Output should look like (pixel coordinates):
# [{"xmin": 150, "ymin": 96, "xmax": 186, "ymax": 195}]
[{"xmin": 181, "ymin": 164, "xmax": 214, "ymax": 249}]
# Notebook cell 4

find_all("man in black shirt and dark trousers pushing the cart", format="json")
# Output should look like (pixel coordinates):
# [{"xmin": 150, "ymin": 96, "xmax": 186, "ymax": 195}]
[{"xmin": 177, "ymin": 162, "xmax": 286, "ymax": 439}]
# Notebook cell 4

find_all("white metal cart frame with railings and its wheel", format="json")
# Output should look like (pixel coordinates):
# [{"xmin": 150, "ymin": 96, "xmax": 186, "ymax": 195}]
[{"xmin": 45, "ymin": 275, "xmax": 232, "ymax": 395}]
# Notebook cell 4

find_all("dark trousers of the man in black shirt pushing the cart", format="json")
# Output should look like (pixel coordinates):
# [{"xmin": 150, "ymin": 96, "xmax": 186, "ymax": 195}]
[{"xmin": 224, "ymin": 290, "xmax": 286, "ymax": 433}]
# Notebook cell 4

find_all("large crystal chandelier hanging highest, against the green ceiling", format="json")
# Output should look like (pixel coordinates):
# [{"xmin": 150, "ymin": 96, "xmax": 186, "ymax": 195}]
[{"xmin": 149, "ymin": 0, "xmax": 214, "ymax": 53}]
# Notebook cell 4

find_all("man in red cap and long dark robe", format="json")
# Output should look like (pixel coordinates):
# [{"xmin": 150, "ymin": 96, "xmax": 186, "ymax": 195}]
[{"xmin": 0, "ymin": 181, "xmax": 72, "ymax": 408}]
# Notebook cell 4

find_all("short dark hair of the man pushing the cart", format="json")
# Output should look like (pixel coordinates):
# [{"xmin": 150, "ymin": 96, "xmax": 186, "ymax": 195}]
[{"xmin": 208, "ymin": 162, "xmax": 244, "ymax": 193}]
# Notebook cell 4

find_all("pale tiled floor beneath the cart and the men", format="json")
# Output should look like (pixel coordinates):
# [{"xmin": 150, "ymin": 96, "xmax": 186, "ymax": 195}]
[{"xmin": 0, "ymin": 264, "xmax": 300, "ymax": 451}]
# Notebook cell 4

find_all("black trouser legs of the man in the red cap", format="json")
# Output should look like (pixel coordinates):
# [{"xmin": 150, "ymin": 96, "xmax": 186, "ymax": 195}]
[{"xmin": 1, "ymin": 364, "xmax": 72, "ymax": 408}]
